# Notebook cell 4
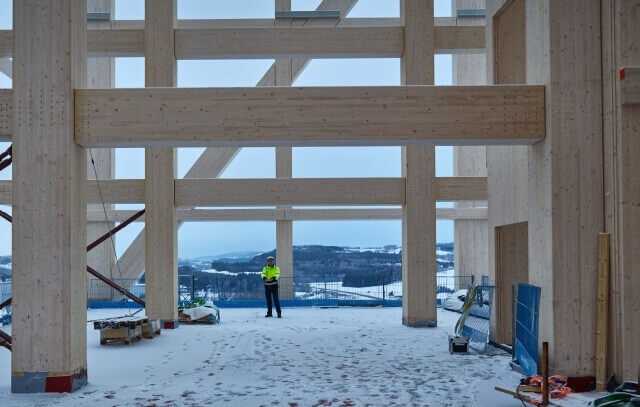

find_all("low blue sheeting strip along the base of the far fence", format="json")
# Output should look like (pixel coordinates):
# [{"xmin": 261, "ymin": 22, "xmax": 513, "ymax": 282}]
[{"xmin": 88, "ymin": 299, "xmax": 402, "ymax": 308}]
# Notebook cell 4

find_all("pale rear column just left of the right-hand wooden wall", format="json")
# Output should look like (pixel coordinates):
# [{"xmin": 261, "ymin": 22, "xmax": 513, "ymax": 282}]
[{"xmin": 452, "ymin": 0, "xmax": 489, "ymax": 284}]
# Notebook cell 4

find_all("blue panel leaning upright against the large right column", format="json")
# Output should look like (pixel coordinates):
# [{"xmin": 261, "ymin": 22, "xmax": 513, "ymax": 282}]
[{"xmin": 513, "ymin": 284, "xmax": 541, "ymax": 376}]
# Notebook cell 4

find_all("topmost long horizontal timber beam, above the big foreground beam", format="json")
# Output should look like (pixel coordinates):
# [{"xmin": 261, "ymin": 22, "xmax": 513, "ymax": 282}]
[{"xmin": 0, "ymin": 18, "xmax": 485, "ymax": 59}]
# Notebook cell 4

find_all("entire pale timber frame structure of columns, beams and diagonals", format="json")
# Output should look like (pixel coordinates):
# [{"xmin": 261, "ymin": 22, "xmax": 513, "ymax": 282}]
[{"xmin": 0, "ymin": 0, "xmax": 640, "ymax": 392}]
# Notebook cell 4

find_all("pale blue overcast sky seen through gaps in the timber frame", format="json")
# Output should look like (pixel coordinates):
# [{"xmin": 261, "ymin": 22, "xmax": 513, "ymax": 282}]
[{"xmin": 0, "ymin": 0, "xmax": 460, "ymax": 257}]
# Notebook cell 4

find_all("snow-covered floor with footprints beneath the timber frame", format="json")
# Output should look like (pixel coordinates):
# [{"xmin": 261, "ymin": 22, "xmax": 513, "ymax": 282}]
[{"xmin": 0, "ymin": 308, "xmax": 596, "ymax": 407}]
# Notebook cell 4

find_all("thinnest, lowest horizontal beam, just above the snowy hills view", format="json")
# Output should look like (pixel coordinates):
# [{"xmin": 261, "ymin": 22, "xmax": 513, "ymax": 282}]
[{"xmin": 87, "ymin": 208, "xmax": 487, "ymax": 222}]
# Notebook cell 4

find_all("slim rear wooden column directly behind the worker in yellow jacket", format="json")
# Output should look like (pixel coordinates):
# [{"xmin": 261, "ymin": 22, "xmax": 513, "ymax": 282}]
[{"xmin": 275, "ymin": 0, "xmax": 295, "ymax": 299}]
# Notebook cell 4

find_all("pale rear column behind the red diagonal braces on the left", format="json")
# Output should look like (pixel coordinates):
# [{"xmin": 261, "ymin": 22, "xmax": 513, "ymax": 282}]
[{"xmin": 87, "ymin": 0, "xmax": 116, "ymax": 299}]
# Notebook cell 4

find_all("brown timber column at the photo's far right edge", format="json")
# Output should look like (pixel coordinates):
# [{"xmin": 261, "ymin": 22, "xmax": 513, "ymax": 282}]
[{"xmin": 602, "ymin": 0, "xmax": 640, "ymax": 381}]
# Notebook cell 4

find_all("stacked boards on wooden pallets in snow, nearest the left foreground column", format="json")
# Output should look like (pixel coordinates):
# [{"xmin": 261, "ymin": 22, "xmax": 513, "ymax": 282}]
[{"xmin": 93, "ymin": 316, "xmax": 160, "ymax": 345}]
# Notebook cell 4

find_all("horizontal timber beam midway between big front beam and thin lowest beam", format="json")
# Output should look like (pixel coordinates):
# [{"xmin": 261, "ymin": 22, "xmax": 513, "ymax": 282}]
[{"xmin": 0, "ymin": 177, "xmax": 487, "ymax": 207}]
